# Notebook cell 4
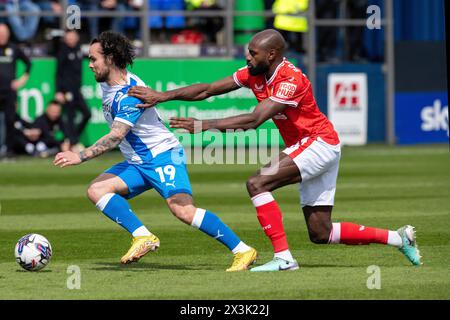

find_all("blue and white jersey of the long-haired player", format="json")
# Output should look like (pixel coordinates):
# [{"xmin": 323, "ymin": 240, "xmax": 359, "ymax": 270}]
[{"xmin": 100, "ymin": 72, "xmax": 180, "ymax": 164}]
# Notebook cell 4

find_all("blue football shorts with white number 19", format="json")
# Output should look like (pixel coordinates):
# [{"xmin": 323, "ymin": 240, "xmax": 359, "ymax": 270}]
[{"xmin": 105, "ymin": 147, "xmax": 192, "ymax": 199}]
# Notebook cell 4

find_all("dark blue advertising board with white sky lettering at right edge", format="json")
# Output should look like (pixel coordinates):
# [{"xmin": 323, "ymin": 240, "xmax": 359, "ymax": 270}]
[{"xmin": 395, "ymin": 92, "xmax": 449, "ymax": 144}]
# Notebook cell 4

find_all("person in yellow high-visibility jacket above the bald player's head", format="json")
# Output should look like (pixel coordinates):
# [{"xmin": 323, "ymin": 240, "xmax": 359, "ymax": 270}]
[{"xmin": 272, "ymin": 0, "xmax": 309, "ymax": 53}]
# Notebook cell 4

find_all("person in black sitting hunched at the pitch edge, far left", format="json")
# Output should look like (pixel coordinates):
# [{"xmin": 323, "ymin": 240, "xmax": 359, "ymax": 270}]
[{"xmin": 14, "ymin": 100, "xmax": 70, "ymax": 158}]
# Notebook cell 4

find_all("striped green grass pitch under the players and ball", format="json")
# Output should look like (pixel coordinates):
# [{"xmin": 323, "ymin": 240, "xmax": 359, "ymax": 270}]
[{"xmin": 0, "ymin": 145, "xmax": 450, "ymax": 300}]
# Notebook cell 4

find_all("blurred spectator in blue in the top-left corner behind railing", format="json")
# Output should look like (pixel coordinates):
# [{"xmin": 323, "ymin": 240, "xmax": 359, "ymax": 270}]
[{"xmin": 4, "ymin": 0, "xmax": 41, "ymax": 42}]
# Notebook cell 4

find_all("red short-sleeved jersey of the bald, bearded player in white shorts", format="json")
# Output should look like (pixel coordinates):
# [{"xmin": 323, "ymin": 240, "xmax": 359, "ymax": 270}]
[{"xmin": 233, "ymin": 58, "xmax": 339, "ymax": 147}]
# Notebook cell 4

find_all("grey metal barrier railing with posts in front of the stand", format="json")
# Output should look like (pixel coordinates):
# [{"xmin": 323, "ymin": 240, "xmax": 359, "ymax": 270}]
[{"xmin": 0, "ymin": 0, "xmax": 395, "ymax": 144}]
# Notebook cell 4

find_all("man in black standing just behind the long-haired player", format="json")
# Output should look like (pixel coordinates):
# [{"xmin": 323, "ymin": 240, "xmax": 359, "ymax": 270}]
[{"xmin": 55, "ymin": 30, "xmax": 91, "ymax": 149}]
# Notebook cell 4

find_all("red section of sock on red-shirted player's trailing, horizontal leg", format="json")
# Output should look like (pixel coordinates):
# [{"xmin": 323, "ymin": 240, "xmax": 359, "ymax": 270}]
[{"xmin": 340, "ymin": 222, "xmax": 389, "ymax": 245}]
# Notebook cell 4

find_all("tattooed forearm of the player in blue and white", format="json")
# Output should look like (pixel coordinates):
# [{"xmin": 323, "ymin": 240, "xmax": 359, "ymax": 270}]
[{"xmin": 80, "ymin": 121, "xmax": 131, "ymax": 162}]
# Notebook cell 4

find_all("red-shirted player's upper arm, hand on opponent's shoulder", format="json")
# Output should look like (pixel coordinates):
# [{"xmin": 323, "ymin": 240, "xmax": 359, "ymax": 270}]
[{"xmin": 127, "ymin": 77, "xmax": 240, "ymax": 108}]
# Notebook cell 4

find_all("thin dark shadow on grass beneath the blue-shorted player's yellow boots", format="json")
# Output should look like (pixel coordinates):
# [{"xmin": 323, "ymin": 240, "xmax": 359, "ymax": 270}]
[{"xmin": 91, "ymin": 262, "xmax": 215, "ymax": 272}]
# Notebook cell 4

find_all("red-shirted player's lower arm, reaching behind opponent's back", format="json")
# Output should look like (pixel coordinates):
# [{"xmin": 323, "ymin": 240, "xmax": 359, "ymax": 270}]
[{"xmin": 169, "ymin": 99, "xmax": 286, "ymax": 133}]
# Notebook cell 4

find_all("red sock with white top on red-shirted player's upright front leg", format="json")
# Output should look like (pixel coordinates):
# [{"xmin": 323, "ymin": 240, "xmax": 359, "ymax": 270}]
[{"xmin": 252, "ymin": 192, "xmax": 289, "ymax": 253}]
